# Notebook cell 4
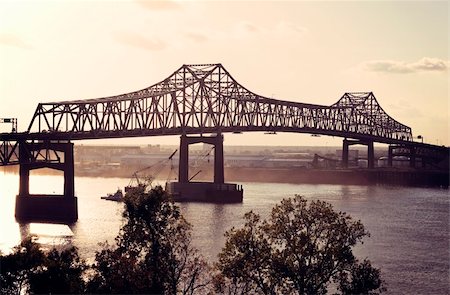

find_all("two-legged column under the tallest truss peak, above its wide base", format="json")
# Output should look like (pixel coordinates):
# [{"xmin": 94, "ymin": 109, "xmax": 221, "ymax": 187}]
[{"xmin": 178, "ymin": 134, "xmax": 225, "ymax": 184}]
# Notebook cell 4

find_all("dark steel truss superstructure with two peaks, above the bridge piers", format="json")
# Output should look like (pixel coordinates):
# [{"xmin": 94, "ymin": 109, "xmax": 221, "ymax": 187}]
[{"xmin": 24, "ymin": 64, "xmax": 412, "ymax": 143}]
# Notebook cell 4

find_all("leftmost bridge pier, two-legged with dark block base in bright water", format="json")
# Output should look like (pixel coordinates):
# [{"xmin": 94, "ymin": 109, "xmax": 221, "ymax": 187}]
[{"xmin": 15, "ymin": 141, "xmax": 78, "ymax": 223}]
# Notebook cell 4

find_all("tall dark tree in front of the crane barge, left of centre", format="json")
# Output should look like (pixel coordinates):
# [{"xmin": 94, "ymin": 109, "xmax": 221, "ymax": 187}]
[{"xmin": 88, "ymin": 186, "xmax": 213, "ymax": 294}]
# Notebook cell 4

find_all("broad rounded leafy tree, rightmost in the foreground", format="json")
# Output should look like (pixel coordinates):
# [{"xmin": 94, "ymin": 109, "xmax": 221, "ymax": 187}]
[{"xmin": 215, "ymin": 196, "xmax": 384, "ymax": 294}]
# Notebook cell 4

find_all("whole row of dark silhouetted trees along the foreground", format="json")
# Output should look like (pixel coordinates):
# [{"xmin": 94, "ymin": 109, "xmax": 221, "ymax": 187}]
[{"xmin": 0, "ymin": 187, "xmax": 385, "ymax": 294}]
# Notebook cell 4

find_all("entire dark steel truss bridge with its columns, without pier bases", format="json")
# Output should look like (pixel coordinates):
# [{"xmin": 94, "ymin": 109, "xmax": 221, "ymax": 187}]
[{"xmin": 0, "ymin": 64, "xmax": 448, "ymax": 222}]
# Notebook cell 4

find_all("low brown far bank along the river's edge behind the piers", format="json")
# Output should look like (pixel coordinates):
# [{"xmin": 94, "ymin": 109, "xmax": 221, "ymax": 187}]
[{"xmin": 3, "ymin": 167, "xmax": 449, "ymax": 188}]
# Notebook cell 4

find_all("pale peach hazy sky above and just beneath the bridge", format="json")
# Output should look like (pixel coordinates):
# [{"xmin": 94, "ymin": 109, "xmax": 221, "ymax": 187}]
[{"xmin": 0, "ymin": 0, "xmax": 450, "ymax": 145}]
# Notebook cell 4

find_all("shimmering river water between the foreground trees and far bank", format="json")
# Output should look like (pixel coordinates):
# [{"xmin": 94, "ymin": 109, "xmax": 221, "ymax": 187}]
[{"xmin": 0, "ymin": 171, "xmax": 450, "ymax": 294}]
